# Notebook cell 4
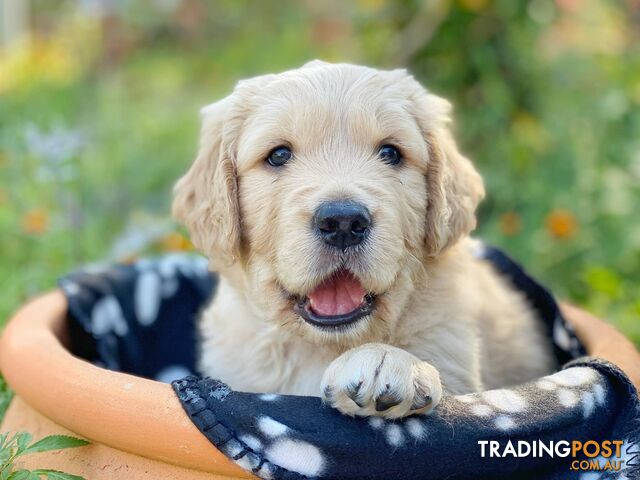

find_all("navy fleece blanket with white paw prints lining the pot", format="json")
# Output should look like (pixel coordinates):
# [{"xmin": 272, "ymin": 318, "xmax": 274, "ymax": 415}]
[{"xmin": 60, "ymin": 247, "xmax": 640, "ymax": 479}]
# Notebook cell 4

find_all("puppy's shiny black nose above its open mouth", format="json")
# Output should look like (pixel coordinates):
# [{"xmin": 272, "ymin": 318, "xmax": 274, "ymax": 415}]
[{"xmin": 313, "ymin": 202, "xmax": 371, "ymax": 250}]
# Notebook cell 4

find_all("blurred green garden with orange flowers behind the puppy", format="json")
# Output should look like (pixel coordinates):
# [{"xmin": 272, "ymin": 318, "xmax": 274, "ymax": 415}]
[{"xmin": 0, "ymin": 0, "xmax": 640, "ymax": 358}]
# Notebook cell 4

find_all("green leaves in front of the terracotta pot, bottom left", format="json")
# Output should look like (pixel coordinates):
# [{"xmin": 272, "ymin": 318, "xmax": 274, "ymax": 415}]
[{"xmin": 0, "ymin": 432, "xmax": 89, "ymax": 480}]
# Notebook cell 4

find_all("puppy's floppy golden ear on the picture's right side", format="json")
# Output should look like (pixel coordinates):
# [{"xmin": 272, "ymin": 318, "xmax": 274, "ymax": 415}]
[{"xmin": 404, "ymin": 78, "xmax": 485, "ymax": 256}]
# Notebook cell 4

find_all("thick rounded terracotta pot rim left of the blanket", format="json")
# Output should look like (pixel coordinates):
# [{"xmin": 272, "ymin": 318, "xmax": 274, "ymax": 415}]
[{"xmin": 0, "ymin": 290, "xmax": 255, "ymax": 478}]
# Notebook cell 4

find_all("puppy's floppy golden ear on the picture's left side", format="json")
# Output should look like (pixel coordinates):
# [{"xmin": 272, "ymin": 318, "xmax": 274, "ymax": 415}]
[{"xmin": 172, "ymin": 96, "xmax": 240, "ymax": 268}]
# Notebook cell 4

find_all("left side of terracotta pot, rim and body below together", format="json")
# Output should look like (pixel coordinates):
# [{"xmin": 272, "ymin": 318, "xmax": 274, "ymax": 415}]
[{"xmin": 0, "ymin": 291, "xmax": 254, "ymax": 480}]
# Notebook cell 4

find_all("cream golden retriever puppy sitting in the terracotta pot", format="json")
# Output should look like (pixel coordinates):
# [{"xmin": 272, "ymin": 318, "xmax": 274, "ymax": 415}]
[{"xmin": 173, "ymin": 61, "xmax": 553, "ymax": 418}]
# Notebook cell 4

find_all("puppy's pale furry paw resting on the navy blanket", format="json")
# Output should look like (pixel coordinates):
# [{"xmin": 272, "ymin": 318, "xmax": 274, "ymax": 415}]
[{"xmin": 321, "ymin": 343, "xmax": 442, "ymax": 418}]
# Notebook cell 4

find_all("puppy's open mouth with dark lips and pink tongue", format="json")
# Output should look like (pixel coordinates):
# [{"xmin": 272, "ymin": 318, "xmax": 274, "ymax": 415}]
[{"xmin": 294, "ymin": 270, "xmax": 375, "ymax": 328}]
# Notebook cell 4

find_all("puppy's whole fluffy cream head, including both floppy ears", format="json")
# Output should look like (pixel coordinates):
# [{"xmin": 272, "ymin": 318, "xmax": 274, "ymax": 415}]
[{"xmin": 173, "ymin": 62, "xmax": 484, "ymax": 345}]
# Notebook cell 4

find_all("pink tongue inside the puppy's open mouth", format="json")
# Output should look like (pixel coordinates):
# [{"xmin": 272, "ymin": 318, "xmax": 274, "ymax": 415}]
[{"xmin": 309, "ymin": 271, "xmax": 365, "ymax": 316}]
